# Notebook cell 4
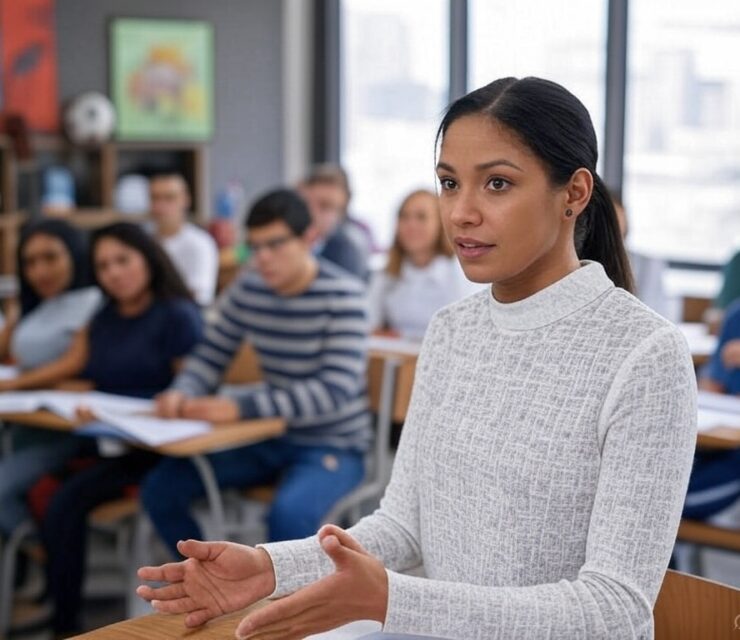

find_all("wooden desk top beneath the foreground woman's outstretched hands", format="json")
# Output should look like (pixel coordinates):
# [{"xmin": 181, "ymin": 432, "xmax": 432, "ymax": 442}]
[{"xmin": 75, "ymin": 603, "xmax": 264, "ymax": 640}]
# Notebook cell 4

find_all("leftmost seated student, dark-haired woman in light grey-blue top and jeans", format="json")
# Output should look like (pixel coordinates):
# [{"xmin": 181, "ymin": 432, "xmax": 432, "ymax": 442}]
[{"xmin": 0, "ymin": 220, "xmax": 101, "ymax": 538}]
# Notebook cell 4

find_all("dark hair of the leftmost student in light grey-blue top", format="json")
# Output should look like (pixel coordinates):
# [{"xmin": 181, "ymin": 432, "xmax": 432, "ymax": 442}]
[{"xmin": 16, "ymin": 220, "xmax": 92, "ymax": 316}]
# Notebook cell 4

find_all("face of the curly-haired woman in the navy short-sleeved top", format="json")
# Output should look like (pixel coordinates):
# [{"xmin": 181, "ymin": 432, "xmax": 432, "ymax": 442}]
[{"xmin": 93, "ymin": 237, "xmax": 150, "ymax": 303}]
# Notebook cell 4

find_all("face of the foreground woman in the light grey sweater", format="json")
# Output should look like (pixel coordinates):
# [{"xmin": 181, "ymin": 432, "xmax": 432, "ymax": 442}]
[{"xmin": 437, "ymin": 115, "xmax": 575, "ymax": 284}]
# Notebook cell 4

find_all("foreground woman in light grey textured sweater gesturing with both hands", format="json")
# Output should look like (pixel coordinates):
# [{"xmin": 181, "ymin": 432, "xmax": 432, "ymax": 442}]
[{"xmin": 139, "ymin": 78, "xmax": 696, "ymax": 640}]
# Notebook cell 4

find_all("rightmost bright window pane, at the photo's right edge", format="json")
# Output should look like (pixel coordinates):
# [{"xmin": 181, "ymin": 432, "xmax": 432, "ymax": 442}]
[{"xmin": 624, "ymin": 0, "xmax": 740, "ymax": 264}]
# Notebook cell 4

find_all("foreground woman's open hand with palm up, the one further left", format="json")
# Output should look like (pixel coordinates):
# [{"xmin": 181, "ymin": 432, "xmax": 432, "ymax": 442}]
[{"xmin": 136, "ymin": 540, "xmax": 275, "ymax": 627}]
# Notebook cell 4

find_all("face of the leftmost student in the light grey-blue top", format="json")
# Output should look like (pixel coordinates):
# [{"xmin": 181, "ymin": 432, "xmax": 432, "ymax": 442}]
[{"xmin": 21, "ymin": 233, "xmax": 74, "ymax": 299}]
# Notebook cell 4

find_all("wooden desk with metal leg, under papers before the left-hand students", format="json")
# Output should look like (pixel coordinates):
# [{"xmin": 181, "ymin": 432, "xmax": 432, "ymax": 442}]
[{"xmin": 0, "ymin": 411, "xmax": 285, "ymax": 539}]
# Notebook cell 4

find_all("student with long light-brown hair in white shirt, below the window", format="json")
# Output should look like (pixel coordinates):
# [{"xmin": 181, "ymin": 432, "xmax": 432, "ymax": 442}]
[{"xmin": 369, "ymin": 189, "xmax": 480, "ymax": 340}]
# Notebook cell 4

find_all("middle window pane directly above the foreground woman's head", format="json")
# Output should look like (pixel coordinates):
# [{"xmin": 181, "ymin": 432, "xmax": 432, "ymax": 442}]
[{"xmin": 468, "ymin": 0, "xmax": 607, "ymax": 161}]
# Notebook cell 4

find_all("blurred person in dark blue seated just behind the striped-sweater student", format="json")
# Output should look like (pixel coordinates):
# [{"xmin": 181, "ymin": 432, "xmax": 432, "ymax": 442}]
[{"xmin": 298, "ymin": 164, "xmax": 373, "ymax": 281}]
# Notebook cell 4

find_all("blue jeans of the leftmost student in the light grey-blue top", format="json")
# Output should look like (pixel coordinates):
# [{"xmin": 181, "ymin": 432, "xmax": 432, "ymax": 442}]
[{"xmin": 0, "ymin": 433, "xmax": 95, "ymax": 535}]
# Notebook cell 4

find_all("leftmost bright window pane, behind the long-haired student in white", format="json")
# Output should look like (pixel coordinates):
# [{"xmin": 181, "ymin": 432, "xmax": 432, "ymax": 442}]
[{"xmin": 341, "ymin": 0, "xmax": 449, "ymax": 247}]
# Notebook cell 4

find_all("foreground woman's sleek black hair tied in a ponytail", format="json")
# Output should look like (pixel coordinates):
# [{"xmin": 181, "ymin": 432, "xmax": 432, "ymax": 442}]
[{"xmin": 437, "ymin": 77, "xmax": 634, "ymax": 291}]
